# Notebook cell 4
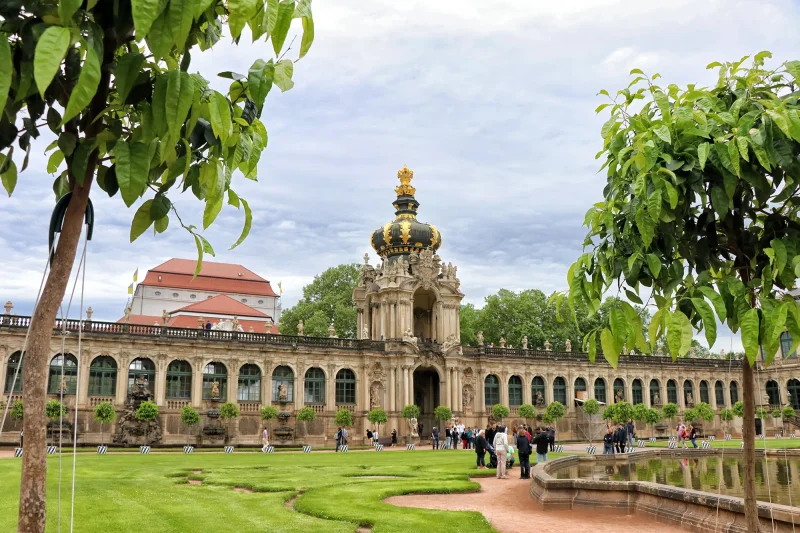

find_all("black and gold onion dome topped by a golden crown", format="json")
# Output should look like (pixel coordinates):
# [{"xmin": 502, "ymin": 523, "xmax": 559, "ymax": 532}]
[{"xmin": 371, "ymin": 166, "xmax": 442, "ymax": 258}]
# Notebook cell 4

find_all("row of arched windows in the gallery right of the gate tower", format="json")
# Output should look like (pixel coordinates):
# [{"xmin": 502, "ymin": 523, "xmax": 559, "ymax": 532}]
[{"xmin": 484, "ymin": 374, "xmax": 756, "ymax": 408}]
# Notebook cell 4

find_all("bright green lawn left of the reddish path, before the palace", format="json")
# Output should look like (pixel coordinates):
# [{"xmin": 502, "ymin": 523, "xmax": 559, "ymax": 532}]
[{"xmin": 0, "ymin": 450, "xmax": 556, "ymax": 533}]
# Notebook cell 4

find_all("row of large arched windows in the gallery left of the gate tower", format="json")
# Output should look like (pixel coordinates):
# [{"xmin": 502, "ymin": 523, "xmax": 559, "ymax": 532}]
[{"xmin": 4, "ymin": 352, "xmax": 356, "ymax": 404}]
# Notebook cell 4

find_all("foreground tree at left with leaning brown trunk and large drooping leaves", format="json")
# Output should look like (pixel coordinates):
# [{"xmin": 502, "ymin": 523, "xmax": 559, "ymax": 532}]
[{"xmin": 0, "ymin": 0, "xmax": 314, "ymax": 532}]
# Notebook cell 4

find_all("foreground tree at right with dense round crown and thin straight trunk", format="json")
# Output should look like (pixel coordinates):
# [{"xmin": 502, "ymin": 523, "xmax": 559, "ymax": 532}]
[{"xmin": 558, "ymin": 52, "xmax": 800, "ymax": 531}]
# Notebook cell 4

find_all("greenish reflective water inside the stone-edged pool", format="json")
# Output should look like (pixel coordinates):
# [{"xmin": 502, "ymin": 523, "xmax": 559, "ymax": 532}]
[{"xmin": 550, "ymin": 457, "xmax": 800, "ymax": 506}]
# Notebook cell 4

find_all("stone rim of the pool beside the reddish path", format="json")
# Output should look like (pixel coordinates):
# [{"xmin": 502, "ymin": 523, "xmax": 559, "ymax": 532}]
[{"xmin": 530, "ymin": 449, "xmax": 800, "ymax": 533}]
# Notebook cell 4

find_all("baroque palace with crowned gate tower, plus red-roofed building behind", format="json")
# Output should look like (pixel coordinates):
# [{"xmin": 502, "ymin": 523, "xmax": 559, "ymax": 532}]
[{"xmin": 0, "ymin": 168, "xmax": 800, "ymax": 445}]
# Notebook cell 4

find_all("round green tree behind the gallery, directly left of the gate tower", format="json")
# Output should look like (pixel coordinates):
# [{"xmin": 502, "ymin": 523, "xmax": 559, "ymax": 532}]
[{"xmin": 280, "ymin": 264, "xmax": 361, "ymax": 338}]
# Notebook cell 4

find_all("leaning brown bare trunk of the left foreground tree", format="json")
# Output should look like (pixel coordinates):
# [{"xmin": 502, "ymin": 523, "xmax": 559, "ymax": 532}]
[{"xmin": 17, "ymin": 180, "xmax": 91, "ymax": 533}]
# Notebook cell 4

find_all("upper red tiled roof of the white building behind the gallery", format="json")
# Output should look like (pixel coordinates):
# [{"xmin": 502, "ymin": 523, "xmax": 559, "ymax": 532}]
[{"xmin": 141, "ymin": 259, "xmax": 277, "ymax": 296}]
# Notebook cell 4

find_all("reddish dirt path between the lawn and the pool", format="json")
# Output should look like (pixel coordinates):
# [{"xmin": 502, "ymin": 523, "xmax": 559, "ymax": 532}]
[{"xmin": 384, "ymin": 471, "xmax": 676, "ymax": 533}]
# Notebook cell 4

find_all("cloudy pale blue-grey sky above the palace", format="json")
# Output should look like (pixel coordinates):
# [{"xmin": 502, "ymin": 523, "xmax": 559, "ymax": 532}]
[{"xmin": 0, "ymin": 0, "xmax": 800, "ymax": 350}]
